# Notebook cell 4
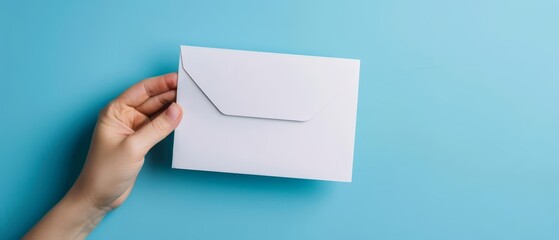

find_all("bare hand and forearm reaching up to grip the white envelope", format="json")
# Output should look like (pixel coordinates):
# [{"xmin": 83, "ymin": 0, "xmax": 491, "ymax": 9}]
[{"xmin": 23, "ymin": 73, "xmax": 182, "ymax": 239}]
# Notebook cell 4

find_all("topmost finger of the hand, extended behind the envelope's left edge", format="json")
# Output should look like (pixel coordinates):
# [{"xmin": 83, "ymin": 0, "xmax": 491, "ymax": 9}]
[{"xmin": 116, "ymin": 73, "xmax": 177, "ymax": 107}]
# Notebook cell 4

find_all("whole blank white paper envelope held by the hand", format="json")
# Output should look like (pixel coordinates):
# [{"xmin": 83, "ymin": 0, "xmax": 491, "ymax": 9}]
[{"xmin": 173, "ymin": 46, "xmax": 360, "ymax": 182}]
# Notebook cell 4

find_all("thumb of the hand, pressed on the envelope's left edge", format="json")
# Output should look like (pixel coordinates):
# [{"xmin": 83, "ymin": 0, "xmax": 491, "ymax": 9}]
[{"xmin": 126, "ymin": 103, "xmax": 182, "ymax": 153}]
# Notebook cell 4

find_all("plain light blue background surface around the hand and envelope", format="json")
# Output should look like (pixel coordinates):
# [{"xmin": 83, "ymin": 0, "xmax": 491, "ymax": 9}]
[{"xmin": 0, "ymin": 0, "xmax": 559, "ymax": 239}]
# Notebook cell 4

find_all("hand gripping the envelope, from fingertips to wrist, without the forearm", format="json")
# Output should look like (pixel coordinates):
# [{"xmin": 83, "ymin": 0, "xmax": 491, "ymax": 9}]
[{"xmin": 71, "ymin": 73, "xmax": 182, "ymax": 210}]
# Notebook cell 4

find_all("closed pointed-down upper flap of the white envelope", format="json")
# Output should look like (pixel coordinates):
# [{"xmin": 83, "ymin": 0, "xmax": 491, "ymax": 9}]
[{"xmin": 181, "ymin": 46, "xmax": 356, "ymax": 121}]
